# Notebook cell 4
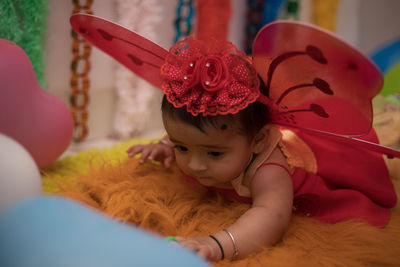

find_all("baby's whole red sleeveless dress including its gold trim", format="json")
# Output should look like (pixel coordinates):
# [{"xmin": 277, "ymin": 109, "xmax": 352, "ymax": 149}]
[{"xmin": 185, "ymin": 124, "xmax": 397, "ymax": 227}]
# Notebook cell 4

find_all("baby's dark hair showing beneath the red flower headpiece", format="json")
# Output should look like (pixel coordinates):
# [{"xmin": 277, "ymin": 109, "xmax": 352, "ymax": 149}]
[{"xmin": 161, "ymin": 76, "xmax": 269, "ymax": 138}]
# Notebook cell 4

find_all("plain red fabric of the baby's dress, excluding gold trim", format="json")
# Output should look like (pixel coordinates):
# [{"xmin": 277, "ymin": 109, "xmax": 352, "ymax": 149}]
[{"xmin": 184, "ymin": 126, "xmax": 397, "ymax": 227}]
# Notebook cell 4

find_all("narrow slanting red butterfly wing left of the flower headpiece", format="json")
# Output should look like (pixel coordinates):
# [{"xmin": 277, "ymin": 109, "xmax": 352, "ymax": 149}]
[{"xmin": 70, "ymin": 14, "xmax": 168, "ymax": 88}]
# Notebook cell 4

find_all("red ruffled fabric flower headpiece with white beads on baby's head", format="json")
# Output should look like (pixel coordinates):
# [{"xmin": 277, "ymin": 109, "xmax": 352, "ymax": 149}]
[{"xmin": 161, "ymin": 37, "xmax": 260, "ymax": 116}]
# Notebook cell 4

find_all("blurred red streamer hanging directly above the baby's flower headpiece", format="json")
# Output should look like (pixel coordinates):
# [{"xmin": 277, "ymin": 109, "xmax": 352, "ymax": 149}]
[{"xmin": 196, "ymin": 0, "xmax": 231, "ymax": 40}]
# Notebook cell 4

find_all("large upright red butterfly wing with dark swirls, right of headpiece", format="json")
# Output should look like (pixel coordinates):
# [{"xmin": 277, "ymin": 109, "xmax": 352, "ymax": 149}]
[{"xmin": 253, "ymin": 21, "xmax": 383, "ymax": 136}]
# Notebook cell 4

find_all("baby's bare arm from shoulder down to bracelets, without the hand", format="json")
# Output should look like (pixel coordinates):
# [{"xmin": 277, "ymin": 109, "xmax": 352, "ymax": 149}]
[{"xmin": 221, "ymin": 149, "xmax": 293, "ymax": 257}]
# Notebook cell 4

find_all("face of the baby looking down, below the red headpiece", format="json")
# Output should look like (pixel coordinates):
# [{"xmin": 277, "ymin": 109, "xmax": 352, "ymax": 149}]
[{"xmin": 164, "ymin": 119, "xmax": 253, "ymax": 188}]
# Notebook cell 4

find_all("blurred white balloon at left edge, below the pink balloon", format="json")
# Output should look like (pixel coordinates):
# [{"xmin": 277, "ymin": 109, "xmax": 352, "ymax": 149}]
[{"xmin": 0, "ymin": 133, "xmax": 42, "ymax": 213}]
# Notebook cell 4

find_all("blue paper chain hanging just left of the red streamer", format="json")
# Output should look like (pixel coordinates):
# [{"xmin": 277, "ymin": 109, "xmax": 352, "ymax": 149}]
[{"xmin": 174, "ymin": 0, "xmax": 193, "ymax": 43}]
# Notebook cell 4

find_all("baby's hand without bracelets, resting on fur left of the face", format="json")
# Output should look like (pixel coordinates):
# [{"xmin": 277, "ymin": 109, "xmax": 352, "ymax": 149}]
[{"xmin": 126, "ymin": 143, "xmax": 175, "ymax": 167}]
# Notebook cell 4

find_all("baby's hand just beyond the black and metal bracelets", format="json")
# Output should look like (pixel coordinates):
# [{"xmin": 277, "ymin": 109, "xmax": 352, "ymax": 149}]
[{"xmin": 176, "ymin": 236, "xmax": 222, "ymax": 261}]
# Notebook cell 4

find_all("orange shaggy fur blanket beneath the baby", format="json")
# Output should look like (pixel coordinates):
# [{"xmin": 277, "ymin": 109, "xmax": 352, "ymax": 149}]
[{"xmin": 47, "ymin": 159, "xmax": 400, "ymax": 267}]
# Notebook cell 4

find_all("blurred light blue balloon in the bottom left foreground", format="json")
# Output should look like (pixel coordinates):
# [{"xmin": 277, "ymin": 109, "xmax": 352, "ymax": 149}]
[{"xmin": 0, "ymin": 196, "xmax": 209, "ymax": 267}]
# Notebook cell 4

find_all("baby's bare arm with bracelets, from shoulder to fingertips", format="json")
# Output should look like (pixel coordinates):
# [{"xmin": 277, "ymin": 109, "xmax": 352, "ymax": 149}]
[{"xmin": 178, "ymin": 149, "xmax": 293, "ymax": 261}]
